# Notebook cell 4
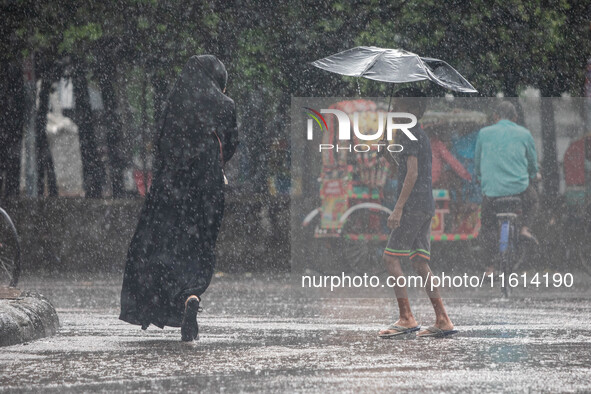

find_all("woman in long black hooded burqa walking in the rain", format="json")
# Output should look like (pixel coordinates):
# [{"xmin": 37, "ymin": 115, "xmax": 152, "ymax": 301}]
[{"xmin": 119, "ymin": 55, "xmax": 238, "ymax": 341}]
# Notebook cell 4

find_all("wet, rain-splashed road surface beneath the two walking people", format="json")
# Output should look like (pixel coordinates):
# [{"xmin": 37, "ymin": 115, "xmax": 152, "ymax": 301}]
[{"xmin": 0, "ymin": 275, "xmax": 591, "ymax": 392}]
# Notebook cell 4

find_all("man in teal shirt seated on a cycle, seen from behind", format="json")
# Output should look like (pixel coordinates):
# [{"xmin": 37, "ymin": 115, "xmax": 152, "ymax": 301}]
[{"xmin": 474, "ymin": 101, "xmax": 539, "ymax": 252}]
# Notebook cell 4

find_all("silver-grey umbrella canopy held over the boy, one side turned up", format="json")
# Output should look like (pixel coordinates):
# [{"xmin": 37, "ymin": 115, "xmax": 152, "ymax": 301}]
[{"xmin": 312, "ymin": 47, "xmax": 477, "ymax": 93}]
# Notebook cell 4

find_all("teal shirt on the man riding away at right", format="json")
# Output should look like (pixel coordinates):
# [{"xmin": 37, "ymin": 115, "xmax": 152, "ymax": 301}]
[{"xmin": 474, "ymin": 119, "xmax": 538, "ymax": 197}]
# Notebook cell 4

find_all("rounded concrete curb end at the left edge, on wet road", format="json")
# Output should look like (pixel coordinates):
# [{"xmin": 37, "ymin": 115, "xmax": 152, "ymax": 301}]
[{"xmin": 0, "ymin": 292, "xmax": 59, "ymax": 346}]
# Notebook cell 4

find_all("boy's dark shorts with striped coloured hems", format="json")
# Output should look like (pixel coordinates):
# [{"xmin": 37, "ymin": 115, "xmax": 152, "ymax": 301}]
[{"xmin": 384, "ymin": 211, "xmax": 433, "ymax": 260}]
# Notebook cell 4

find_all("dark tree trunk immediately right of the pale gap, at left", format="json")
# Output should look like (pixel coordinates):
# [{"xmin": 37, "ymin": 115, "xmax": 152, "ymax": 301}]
[{"xmin": 74, "ymin": 64, "xmax": 105, "ymax": 198}]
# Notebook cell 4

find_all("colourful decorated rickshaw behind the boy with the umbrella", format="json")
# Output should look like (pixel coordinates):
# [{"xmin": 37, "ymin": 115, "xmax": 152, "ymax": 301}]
[{"xmin": 302, "ymin": 100, "xmax": 486, "ymax": 274}]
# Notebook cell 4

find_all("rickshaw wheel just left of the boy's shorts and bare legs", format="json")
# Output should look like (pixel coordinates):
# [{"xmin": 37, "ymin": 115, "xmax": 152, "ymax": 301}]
[{"xmin": 339, "ymin": 209, "xmax": 389, "ymax": 275}]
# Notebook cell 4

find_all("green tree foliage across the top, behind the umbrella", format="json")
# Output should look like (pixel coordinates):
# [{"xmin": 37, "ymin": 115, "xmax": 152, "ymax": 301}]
[{"xmin": 6, "ymin": 0, "xmax": 591, "ymax": 114}]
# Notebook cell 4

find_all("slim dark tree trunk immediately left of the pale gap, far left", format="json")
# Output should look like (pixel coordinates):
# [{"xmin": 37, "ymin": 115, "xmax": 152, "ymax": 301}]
[{"xmin": 35, "ymin": 76, "xmax": 58, "ymax": 197}]
